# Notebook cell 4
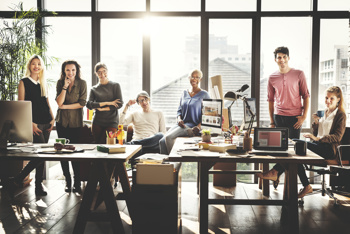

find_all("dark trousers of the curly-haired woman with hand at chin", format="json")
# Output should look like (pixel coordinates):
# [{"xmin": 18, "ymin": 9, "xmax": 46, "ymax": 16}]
[{"xmin": 56, "ymin": 122, "xmax": 81, "ymax": 186}]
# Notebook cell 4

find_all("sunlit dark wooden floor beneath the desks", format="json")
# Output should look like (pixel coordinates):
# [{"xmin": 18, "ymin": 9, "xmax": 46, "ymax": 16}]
[{"xmin": 0, "ymin": 177, "xmax": 350, "ymax": 234}]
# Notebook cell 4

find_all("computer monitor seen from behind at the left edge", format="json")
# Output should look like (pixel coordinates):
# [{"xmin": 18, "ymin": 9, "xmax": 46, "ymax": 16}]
[{"xmin": 0, "ymin": 101, "xmax": 33, "ymax": 149}]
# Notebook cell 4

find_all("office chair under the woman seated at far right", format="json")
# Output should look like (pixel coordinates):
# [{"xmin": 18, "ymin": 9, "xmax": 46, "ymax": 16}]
[{"xmin": 299, "ymin": 127, "xmax": 350, "ymax": 206}]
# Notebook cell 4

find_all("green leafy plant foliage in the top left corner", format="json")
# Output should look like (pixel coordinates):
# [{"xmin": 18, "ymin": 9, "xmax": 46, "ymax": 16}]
[{"xmin": 0, "ymin": 3, "xmax": 57, "ymax": 100}]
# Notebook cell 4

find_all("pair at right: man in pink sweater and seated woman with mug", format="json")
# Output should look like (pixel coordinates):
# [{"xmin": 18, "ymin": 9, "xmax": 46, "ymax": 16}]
[{"xmin": 257, "ymin": 47, "xmax": 346, "ymax": 198}]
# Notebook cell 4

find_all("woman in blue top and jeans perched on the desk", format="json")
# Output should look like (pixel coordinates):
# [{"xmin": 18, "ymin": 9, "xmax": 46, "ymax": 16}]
[{"xmin": 159, "ymin": 70, "xmax": 210, "ymax": 154}]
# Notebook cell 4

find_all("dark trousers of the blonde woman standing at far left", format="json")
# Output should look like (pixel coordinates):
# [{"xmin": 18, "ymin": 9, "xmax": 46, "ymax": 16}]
[{"xmin": 15, "ymin": 124, "xmax": 51, "ymax": 186}]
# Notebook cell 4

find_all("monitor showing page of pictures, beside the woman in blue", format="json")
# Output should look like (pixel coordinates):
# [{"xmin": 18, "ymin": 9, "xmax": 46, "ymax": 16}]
[{"xmin": 201, "ymin": 99, "xmax": 222, "ymax": 134}]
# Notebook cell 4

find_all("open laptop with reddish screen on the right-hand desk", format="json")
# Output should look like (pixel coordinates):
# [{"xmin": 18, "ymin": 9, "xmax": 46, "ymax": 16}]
[{"xmin": 251, "ymin": 128, "xmax": 289, "ymax": 156}]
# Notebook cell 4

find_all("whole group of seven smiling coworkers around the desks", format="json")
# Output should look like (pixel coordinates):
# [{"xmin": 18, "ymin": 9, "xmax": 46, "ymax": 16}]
[{"xmin": 6, "ymin": 47, "xmax": 346, "ymax": 197}]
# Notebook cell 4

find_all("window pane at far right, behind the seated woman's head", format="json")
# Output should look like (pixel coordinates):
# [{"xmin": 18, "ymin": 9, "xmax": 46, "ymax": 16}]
[{"xmin": 318, "ymin": 19, "xmax": 350, "ymax": 126}]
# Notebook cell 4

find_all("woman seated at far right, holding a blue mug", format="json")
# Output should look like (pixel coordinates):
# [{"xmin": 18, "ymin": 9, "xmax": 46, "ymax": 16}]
[{"xmin": 258, "ymin": 86, "xmax": 346, "ymax": 198}]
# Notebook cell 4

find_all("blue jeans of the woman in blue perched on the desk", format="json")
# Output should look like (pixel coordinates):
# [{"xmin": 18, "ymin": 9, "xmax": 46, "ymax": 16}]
[{"xmin": 159, "ymin": 125, "xmax": 190, "ymax": 155}]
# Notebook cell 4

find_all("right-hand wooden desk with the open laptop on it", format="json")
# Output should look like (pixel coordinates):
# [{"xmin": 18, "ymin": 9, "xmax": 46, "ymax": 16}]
[{"xmin": 168, "ymin": 138, "xmax": 324, "ymax": 234}]
